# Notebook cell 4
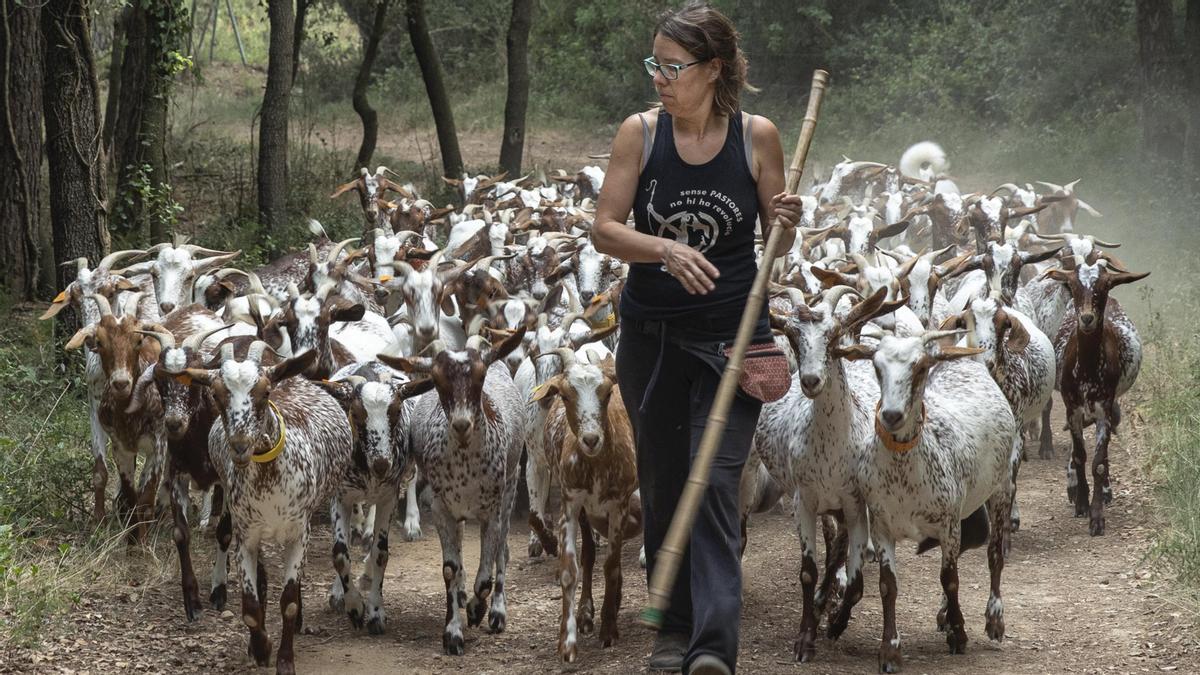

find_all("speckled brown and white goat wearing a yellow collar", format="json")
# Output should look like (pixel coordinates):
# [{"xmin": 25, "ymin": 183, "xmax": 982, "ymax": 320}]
[{"xmin": 184, "ymin": 341, "xmax": 352, "ymax": 673}]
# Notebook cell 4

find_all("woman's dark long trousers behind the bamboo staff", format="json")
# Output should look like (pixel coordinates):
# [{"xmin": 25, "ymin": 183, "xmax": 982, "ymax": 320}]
[{"xmin": 617, "ymin": 329, "xmax": 762, "ymax": 671}]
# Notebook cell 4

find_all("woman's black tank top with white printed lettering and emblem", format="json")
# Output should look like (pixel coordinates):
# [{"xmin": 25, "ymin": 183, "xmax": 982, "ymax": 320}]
[{"xmin": 620, "ymin": 109, "xmax": 769, "ymax": 336}]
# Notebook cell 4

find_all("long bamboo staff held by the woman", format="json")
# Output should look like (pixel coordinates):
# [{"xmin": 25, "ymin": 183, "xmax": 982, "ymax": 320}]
[{"xmin": 638, "ymin": 70, "xmax": 829, "ymax": 629}]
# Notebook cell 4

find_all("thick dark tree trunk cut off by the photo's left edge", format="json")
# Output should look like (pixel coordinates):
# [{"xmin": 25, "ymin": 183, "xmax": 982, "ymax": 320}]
[{"xmin": 0, "ymin": 0, "xmax": 42, "ymax": 300}]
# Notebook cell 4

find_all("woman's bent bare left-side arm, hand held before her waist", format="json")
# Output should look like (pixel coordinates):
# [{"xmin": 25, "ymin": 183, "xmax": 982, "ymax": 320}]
[{"xmin": 592, "ymin": 114, "xmax": 720, "ymax": 295}]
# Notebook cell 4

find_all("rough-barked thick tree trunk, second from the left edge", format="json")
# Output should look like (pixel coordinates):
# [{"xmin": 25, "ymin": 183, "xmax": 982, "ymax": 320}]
[{"xmin": 42, "ymin": 0, "xmax": 109, "ymax": 336}]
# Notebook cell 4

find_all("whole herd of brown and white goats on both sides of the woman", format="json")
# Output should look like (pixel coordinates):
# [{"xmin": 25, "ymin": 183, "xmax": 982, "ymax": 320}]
[{"xmin": 43, "ymin": 143, "xmax": 1146, "ymax": 673}]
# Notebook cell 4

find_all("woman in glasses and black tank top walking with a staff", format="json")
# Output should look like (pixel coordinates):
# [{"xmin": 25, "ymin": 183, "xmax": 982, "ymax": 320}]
[{"xmin": 592, "ymin": 4, "xmax": 800, "ymax": 674}]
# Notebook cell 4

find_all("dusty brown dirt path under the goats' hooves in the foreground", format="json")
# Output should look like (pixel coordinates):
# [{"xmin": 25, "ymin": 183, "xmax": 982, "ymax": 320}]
[{"xmin": 0, "ymin": 398, "xmax": 1200, "ymax": 674}]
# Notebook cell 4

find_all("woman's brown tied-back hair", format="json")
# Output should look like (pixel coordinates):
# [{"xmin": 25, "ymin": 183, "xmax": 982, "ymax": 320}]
[{"xmin": 654, "ymin": 0, "xmax": 758, "ymax": 117}]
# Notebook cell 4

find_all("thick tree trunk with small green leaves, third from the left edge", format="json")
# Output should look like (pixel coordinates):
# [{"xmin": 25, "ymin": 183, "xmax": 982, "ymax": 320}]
[{"xmin": 113, "ymin": 0, "xmax": 184, "ymax": 244}]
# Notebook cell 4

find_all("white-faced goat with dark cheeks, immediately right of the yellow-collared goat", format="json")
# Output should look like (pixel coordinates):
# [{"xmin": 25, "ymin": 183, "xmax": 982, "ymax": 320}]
[{"xmin": 318, "ymin": 363, "xmax": 433, "ymax": 634}]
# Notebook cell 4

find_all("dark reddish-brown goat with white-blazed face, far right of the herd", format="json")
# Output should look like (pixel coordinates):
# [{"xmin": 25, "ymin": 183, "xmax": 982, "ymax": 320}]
[{"xmin": 1044, "ymin": 257, "xmax": 1150, "ymax": 537}]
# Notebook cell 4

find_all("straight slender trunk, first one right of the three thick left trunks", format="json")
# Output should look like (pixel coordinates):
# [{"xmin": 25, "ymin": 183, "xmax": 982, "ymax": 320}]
[{"xmin": 258, "ymin": 0, "xmax": 295, "ymax": 255}]
